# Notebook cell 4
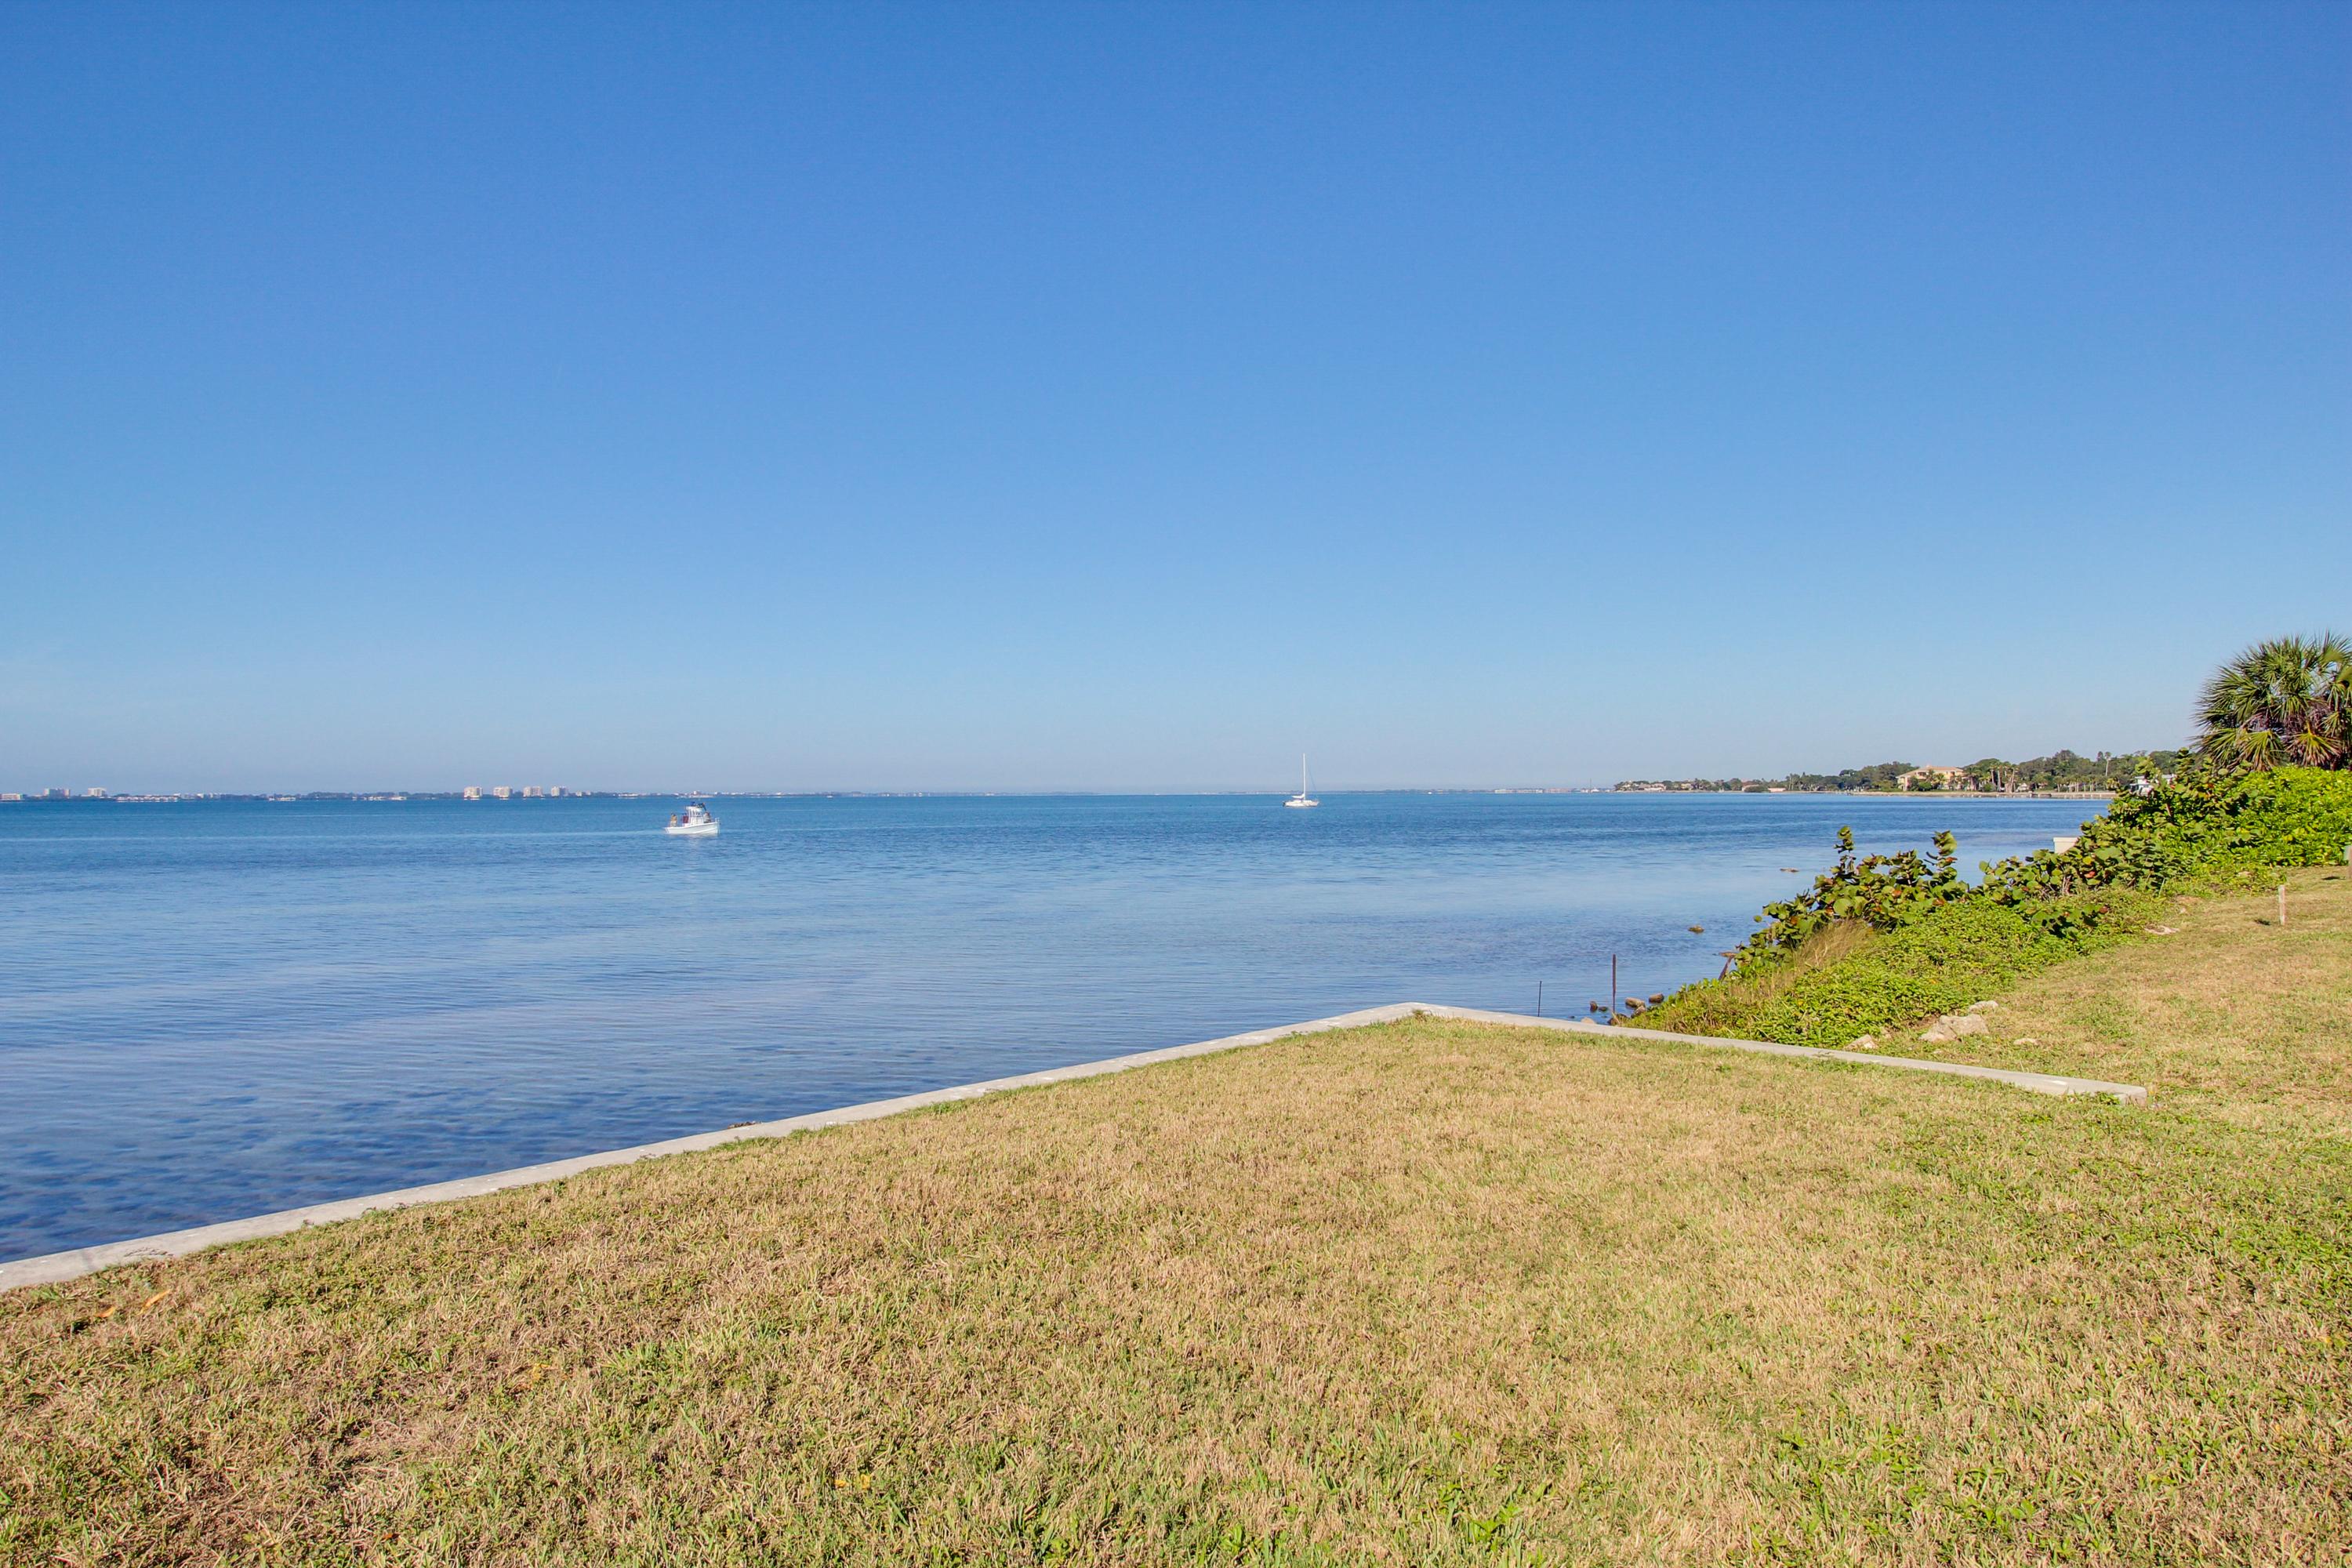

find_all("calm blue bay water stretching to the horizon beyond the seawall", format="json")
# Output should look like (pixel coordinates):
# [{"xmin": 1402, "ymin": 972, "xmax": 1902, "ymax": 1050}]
[{"xmin": 0, "ymin": 794, "xmax": 2098, "ymax": 1258}]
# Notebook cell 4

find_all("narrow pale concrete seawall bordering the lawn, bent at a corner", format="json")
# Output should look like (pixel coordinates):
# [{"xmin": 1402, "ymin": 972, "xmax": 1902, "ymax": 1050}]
[{"xmin": 0, "ymin": 1001, "xmax": 2147, "ymax": 1290}]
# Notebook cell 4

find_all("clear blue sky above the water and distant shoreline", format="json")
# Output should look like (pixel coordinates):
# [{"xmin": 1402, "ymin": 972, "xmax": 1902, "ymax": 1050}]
[{"xmin": 0, "ymin": 0, "xmax": 2352, "ymax": 789}]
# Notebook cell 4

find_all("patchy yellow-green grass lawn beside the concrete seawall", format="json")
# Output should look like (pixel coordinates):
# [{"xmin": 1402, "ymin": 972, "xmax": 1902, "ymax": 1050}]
[{"xmin": 0, "ymin": 872, "xmax": 2352, "ymax": 1563}]
